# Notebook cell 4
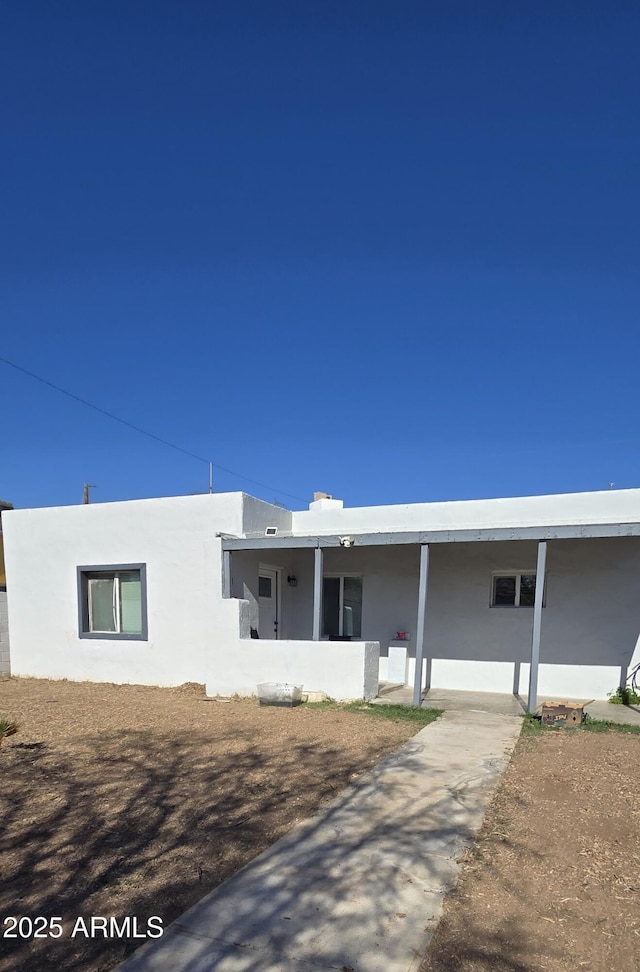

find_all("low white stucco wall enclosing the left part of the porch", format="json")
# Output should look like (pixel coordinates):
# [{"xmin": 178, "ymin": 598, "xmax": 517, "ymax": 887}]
[{"xmin": 207, "ymin": 638, "xmax": 380, "ymax": 701}]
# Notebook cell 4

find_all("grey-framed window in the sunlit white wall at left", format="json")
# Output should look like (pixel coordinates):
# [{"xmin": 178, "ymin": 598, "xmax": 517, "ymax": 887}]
[{"xmin": 78, "ymin": 564, "xmax": 147, "ymax": 641}]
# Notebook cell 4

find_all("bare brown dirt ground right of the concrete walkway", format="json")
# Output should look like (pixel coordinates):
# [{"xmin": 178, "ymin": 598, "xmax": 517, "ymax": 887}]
[{"xmin": 421, "ymin": 729, "xmax": 640, "ymax": 972}]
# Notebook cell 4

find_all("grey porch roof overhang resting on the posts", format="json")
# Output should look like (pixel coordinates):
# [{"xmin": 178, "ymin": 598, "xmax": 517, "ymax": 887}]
[{"xmin": 219, "ymin": 522, "xmax": 640, "ymax": 551}]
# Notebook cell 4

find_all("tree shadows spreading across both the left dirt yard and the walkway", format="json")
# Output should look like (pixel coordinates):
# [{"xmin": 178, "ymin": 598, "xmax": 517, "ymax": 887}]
[{"xmin": 0, "ymin": 708, "xmax": 532, "ymax": 972}]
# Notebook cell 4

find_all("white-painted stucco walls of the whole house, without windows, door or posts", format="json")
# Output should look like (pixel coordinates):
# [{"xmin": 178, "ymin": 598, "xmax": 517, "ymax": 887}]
[{"xmin": 5, "ymin": 490, "xmax": 640, "ymax": 698}]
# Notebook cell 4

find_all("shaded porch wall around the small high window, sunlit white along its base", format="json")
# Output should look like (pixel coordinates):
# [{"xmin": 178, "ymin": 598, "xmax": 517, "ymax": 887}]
[{"xmin": 426, "ymin": 537, "xmax": 640, "ymax": 698}]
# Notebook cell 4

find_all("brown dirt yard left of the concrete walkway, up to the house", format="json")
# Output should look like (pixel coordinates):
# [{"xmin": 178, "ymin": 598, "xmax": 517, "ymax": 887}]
[{"xmin": 0, "ymin": 679, "xmax": 420, "ymax": 972}]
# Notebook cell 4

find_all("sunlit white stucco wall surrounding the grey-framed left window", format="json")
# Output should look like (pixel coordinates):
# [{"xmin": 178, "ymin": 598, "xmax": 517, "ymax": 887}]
[{"xmin": 3, "ymin": 493, "xmax": 248, "ymax": 685}]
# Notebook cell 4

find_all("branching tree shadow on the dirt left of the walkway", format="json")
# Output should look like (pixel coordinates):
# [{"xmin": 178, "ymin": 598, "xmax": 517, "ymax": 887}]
[{"xmin": 0, "ymin": 727, "xmax": 396, "ymax": 972}]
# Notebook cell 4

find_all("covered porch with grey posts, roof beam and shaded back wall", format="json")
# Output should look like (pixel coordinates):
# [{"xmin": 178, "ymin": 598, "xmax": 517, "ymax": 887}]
[{"xmin": 221, "ymin": 523, "xmax": 640, "ymax": 711}]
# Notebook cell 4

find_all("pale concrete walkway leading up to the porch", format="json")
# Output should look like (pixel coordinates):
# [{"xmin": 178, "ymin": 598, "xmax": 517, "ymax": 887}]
[{"xmin": 120, "ymin": 706, "xmax": 521, "ymax": 972}]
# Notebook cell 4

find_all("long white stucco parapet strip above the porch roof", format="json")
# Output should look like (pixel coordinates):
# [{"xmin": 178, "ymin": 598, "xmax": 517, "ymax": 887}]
[{"xmin": 293, "ymin": 489, "xmax": 640, "ymax": 535}]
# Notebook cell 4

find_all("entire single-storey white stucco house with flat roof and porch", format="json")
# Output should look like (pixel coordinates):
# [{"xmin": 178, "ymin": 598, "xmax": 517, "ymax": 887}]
[{"xmin": 3, "ymin": 489, "xmax": 640, "ymax": 708}]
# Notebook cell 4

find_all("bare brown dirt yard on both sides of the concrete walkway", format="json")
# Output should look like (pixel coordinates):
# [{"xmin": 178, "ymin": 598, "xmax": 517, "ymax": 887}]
[{"xmin": 0, "ymin": 679, "xmax": 640, "ymax": 972}]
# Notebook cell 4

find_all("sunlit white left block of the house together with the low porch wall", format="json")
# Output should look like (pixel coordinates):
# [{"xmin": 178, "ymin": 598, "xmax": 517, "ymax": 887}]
[{"xmin": 4, "ymin": 493, "xmax": 379, "ymax": 699}]
